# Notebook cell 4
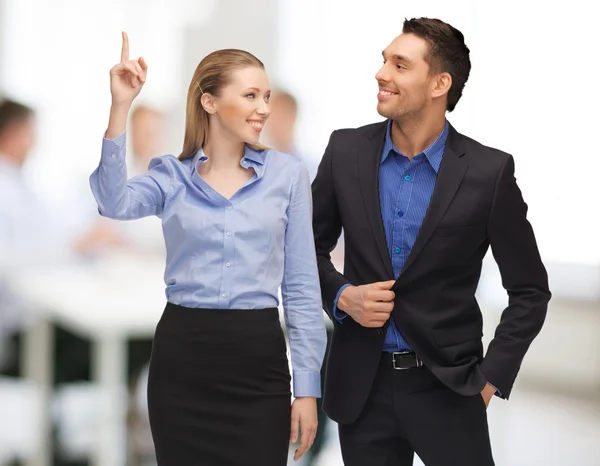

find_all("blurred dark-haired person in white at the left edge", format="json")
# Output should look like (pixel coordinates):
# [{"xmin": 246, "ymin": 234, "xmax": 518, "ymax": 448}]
[{"xmin": 0, "ymin": 100, "xmax": 119, "ymax": 380}]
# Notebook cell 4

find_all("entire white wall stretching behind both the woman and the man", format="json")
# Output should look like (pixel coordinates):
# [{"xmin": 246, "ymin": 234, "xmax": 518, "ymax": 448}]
[{"xmin": 0, "ymin": 0, "xmax": 600, "ymax": 264}]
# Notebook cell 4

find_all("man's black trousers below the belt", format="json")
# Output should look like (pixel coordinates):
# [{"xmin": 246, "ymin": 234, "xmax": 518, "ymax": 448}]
[{"xmin": 339, "ymin": 358, "xmax": 494, "ymax": 466}]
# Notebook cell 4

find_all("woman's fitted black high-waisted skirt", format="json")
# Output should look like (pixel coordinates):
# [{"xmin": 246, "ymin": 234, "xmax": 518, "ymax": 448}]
[{"xmin": 148, "ymin": 303, "xmax": 291, "ymax": 466}]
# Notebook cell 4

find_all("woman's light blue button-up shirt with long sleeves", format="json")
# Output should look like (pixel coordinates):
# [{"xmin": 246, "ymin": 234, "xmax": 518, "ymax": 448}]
[{"xmin": 90, "ymin": 134, "xmax": 326, "ymax": 396}]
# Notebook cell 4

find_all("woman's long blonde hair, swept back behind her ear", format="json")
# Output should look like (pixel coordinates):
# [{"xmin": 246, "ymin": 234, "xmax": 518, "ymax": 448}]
[{"xmin": 179, "ymin": 49, "xmax": 269, "ymax": 160}]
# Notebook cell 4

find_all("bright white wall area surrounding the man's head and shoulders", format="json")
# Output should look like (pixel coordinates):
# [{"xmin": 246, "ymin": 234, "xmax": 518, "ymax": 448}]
[{"xmin": 277, "ymin": 0, "xmax": 600, "ymax": 264}]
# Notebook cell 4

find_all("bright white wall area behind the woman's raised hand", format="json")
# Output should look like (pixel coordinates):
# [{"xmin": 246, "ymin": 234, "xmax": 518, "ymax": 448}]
[{"xmin": 0, "ymin": 0, "xmax": 216, "ymax": 202}]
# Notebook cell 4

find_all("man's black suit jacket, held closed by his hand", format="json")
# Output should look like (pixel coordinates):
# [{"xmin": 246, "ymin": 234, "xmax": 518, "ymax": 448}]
[{"xmin": 312, "ymin": 122, "xmax": 550, "ymax": 424}]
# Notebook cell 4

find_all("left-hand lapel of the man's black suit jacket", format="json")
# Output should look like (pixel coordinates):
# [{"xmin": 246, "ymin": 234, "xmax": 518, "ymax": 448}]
[{"xmin": 357, "ymin": 121, "xmax": 394, "ymax": 279}]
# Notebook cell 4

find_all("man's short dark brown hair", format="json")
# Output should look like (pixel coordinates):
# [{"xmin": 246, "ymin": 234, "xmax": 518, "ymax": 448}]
[{"xmin": 402, "ymin": 18, "xmax": 471, "ymax": 112}]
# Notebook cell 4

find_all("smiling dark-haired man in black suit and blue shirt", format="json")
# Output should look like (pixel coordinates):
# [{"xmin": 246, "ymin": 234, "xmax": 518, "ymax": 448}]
[{"xmin": 313, "ymin": 18, "xmax": 550, "ymax": 466}]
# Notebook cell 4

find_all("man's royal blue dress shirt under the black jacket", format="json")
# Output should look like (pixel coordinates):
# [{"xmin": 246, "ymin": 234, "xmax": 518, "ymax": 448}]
[{"xmin": 334, "ymin": 120, "xmax": 448, "ymax": 352}]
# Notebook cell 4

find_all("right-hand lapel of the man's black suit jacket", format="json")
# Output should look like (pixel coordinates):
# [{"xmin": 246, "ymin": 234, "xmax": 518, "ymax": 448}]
[{"xmin": 399, "ymin": 126, "xmax": 468, "ymax": 279}]
